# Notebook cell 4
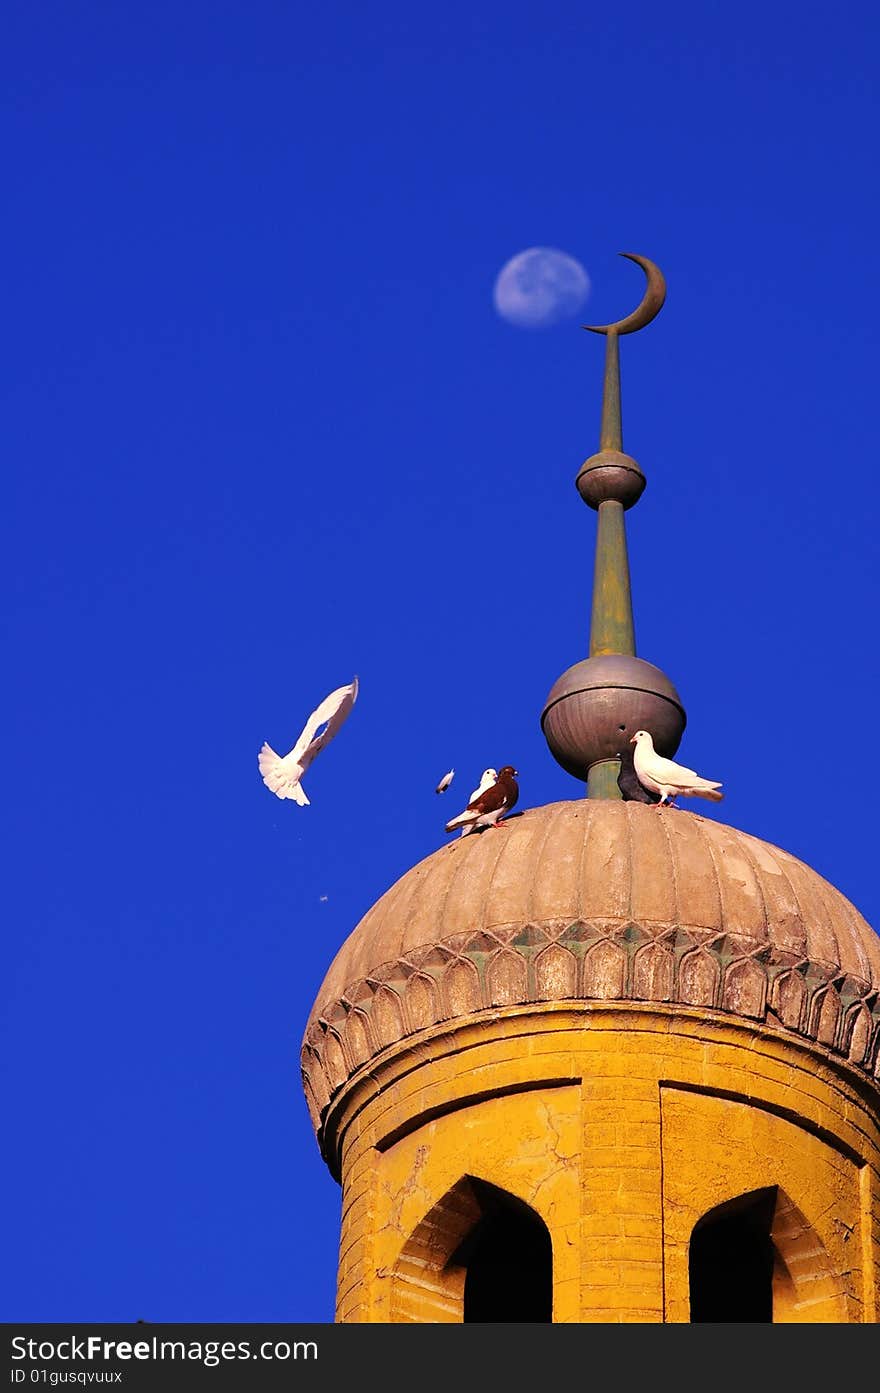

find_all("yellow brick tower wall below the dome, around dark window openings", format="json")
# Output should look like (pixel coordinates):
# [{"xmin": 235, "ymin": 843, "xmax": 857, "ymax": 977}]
[{"xmin": 326, "ymin": 1003, "xmax": 880, "ymax": 1322}]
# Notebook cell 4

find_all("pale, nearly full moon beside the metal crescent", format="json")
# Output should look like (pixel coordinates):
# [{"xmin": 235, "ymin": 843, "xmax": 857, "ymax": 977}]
[{"xmin": 493, "ymin": 247, "xmax": 590, "ymax": 329}]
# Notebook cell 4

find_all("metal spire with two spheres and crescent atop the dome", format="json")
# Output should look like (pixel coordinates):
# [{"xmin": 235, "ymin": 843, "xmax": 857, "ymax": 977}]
[{"xmin": 540, "ymin": 252, "xmax": 686, "ymax": 798}]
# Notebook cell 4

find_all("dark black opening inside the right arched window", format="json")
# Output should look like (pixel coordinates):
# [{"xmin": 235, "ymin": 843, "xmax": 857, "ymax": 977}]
[{"xmin": 688, "ymin": 1188, "xmax": 777, "ymax": 1323}]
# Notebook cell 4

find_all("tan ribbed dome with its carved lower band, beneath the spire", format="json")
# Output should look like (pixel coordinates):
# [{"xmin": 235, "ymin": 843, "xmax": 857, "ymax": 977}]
[{"xmin": 304, "ymin": 800, "xmax": 880, "ymax": 1124}]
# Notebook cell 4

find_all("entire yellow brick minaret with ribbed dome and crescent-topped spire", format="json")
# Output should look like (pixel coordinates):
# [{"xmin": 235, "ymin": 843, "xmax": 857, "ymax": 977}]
[{"xmin": 302, "ymin": 256, "xmax": 880, "ymax": 1323}]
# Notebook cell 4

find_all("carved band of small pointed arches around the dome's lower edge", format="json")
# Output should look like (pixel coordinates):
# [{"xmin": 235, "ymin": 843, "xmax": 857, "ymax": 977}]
[{"xmin": 302, "ymin": 921, "xmax": 880, "ymax": 1126}]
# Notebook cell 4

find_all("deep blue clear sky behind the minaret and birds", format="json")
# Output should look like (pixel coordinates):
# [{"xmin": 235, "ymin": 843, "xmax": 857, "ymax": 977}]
[{"xmin": 6, "ymin": 0, "xmax": 880, "ymax": 1321}]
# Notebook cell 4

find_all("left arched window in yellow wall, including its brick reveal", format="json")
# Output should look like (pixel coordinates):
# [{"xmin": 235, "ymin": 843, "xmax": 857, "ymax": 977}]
[{"xmin": 391, "ymin": 1176, "xmax": 553, "ymax": 1323}]
